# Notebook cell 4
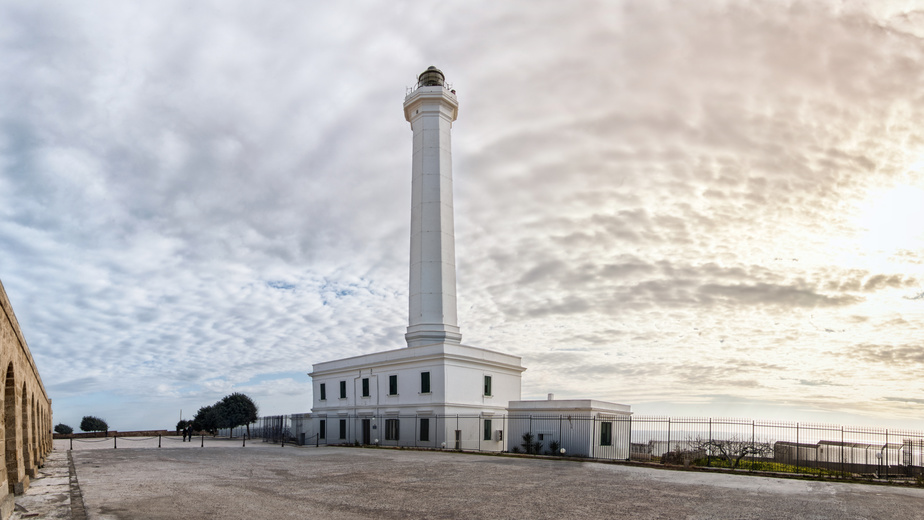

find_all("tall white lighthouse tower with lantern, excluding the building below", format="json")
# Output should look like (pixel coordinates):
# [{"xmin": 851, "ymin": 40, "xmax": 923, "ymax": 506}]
[{"xmin": 404, "ymin": 66, "xmax": 462, "ymax": 347}]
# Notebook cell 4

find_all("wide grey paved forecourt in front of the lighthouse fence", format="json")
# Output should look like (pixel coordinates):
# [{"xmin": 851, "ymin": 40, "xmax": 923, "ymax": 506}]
[{"xmin": 17, "ymin": 440, "xmax": 924, "ymax": 520}]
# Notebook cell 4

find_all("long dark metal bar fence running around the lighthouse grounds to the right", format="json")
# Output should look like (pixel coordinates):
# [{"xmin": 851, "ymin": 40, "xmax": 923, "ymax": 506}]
[{"xmin": 268, "ymin": 414, "xmax": 924, "ymax": 478}]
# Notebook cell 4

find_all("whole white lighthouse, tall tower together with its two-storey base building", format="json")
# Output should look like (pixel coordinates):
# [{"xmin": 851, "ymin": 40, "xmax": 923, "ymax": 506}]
[{"xmin": 307, "ymin": 67, "xmax": 631, "ymax": 450}]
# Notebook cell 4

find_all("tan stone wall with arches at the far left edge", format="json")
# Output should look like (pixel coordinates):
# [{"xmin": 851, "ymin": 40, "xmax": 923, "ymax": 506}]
[{"xmin": 0, "ymin": 283, "xmax": 52, "ymax": 518}]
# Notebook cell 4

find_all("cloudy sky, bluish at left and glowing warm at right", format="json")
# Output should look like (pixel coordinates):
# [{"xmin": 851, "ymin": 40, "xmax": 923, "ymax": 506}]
[{"xmin": 0, "ymin": 0, "xmax": 924, "ymax": 430}]
